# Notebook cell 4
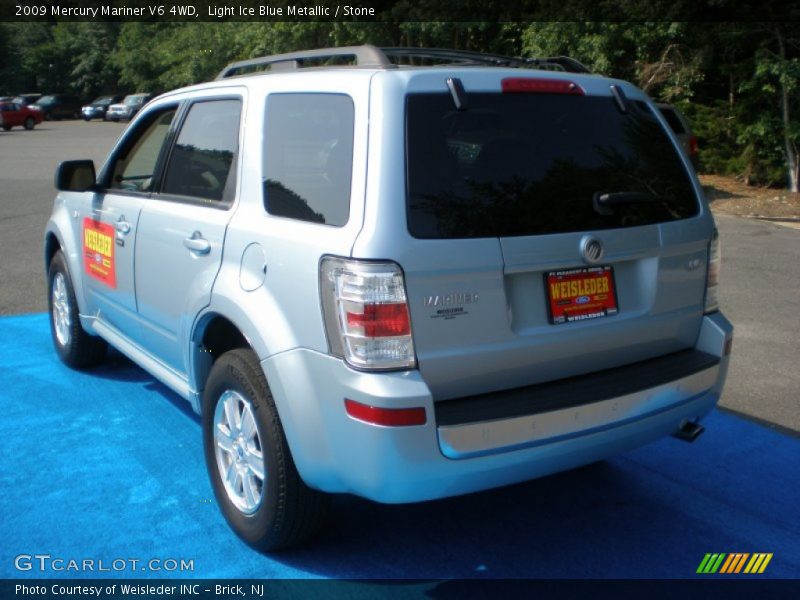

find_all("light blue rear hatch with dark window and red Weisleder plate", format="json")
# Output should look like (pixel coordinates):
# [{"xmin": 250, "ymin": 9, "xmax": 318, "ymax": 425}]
[{"xmin": 399, "ymin": 72, "xmax": 713, "ymax": 400}]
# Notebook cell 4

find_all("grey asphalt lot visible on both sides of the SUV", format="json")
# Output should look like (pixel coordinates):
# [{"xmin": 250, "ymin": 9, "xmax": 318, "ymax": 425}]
[{"xmin": 0, "ymin": 121, "xmax": 800, "ymax": 432}]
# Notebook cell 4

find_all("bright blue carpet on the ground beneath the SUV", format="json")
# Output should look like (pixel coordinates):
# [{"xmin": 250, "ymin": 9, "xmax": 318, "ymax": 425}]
[{"xmin": 0, "ymin": 314, "xmax": 800, "ymax": 579}]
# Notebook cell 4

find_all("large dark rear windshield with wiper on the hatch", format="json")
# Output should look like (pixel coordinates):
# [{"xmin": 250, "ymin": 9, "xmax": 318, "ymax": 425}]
[{"xmin": 406, "ymin": 93, "xmax": 699, "ymax": 238}]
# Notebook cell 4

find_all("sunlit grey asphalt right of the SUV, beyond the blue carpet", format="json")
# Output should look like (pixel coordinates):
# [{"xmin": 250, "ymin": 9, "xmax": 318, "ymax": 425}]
[{"xmin": 717, "ymin": 216, "xmax": 800, "ymax": 432}]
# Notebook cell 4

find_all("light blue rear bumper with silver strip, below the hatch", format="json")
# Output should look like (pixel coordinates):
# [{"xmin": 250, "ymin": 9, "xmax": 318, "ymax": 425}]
[{"xmin": 262, "ymin": 313, "xmax": 733, "ymax": 503}]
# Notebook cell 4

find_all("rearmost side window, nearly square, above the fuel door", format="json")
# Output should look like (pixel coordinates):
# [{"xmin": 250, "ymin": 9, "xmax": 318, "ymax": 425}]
[{"xmin": 263, "ymin": 94, "xmax": 354, "ymax": 227}]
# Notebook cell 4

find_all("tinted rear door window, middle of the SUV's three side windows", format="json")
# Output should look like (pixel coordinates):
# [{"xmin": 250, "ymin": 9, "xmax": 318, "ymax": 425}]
[{"xmin": 161, "ymin": 100, "xmax": 242, "ymax": 202}]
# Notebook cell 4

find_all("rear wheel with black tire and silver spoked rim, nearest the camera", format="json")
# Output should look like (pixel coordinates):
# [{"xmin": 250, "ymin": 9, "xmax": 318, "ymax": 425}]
[{"xmin": 202, "ymin": 348, "xmax": 330, "ymax": 552}]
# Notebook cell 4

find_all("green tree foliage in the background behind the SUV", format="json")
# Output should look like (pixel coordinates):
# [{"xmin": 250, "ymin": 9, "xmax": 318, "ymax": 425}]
[{"xmin": 0, "ymin": 17, "xmax": 800, "ymax": 190}]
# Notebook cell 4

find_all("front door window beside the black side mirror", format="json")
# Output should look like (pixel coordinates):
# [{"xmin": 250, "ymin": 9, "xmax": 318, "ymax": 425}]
[{"xmin": 109, "ymin": 108, "xmax": 175, "ymax": 192}]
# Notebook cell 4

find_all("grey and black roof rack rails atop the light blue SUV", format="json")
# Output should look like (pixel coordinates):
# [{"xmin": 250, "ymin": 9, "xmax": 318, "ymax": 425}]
[{"xmin": 217, "ymin": 44, "xmax": 590, "ymax": 79}]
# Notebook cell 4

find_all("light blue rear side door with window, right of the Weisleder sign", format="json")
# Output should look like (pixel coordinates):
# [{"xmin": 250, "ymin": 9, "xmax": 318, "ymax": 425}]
[{"xmin": 135, "ymin": 95, "xmax": 242, "ymax": 373}]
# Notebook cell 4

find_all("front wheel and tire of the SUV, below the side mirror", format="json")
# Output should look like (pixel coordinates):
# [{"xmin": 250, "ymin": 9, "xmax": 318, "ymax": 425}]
[{"xmin": 47, "ymin": 250, "xmax": 108, "ymax": 369}]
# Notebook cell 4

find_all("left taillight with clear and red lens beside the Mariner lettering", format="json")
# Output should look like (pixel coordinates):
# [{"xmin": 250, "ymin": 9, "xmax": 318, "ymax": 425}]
[{"xmin": 320, "ymin": 257, "xmax": 416, "ymax": 369}]
